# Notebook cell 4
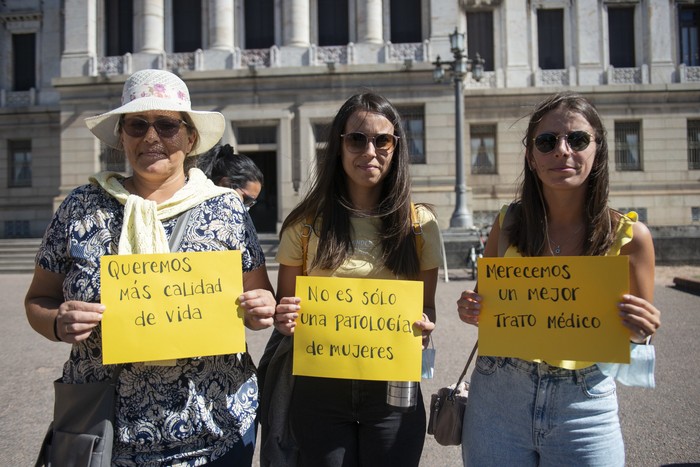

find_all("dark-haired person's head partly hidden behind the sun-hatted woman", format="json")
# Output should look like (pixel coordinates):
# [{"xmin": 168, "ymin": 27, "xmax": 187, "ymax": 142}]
[{"xmin": 197, "ymin": 144, "xmax": 264, "ymax": 209}]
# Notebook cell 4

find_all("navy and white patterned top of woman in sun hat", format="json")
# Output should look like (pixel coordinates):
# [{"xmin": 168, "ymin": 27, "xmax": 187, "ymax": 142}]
[{"xmin": 37, "ymin": 181, "xmax": 265, "ymax": 466}]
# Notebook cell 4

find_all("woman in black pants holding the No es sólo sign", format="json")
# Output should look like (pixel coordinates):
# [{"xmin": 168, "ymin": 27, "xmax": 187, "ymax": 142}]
[{"xmin": 270, "ymin": 93, "xmax": 440, "ymax": 467}]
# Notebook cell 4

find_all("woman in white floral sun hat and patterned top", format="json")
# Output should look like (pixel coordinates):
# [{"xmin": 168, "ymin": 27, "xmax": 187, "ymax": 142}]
[{"xmin": 25, "ymin": 70, "xmax": 275, "ymax": 465}]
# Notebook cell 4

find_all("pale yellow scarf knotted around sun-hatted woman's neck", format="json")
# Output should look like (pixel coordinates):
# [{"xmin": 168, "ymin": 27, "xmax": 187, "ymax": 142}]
[{"xmin": 90, "ymin": 168, "xmax": 231, "ymax": 255}]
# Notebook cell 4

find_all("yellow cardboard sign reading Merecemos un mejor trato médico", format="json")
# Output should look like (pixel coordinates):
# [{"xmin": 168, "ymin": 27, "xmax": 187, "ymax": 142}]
[{"xmin": 478, "ymin": 256, "xmax": 630, "ymax": 363}]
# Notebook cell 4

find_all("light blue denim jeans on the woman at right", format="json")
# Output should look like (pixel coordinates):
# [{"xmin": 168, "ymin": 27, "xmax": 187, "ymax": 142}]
[{"xmin": 462, "ymin": 356, "xmax": 625, "ymax": 467}]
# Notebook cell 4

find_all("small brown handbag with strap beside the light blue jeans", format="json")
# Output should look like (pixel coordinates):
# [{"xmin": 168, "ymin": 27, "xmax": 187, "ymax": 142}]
[{"xmin": 428, "ymin": 341, "xmax": 478, "ymax": 446}]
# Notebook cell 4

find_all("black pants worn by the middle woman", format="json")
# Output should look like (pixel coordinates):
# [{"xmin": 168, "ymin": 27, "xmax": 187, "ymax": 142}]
[{"xmin": 289, "ymin": 376, "xmax": 425, "ymax": 467}]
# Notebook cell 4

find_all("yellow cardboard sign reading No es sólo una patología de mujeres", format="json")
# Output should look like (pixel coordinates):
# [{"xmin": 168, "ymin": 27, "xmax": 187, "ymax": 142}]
[{"xmin": 292, "ymin": 276, "xmax": 423, "ymax": 381}]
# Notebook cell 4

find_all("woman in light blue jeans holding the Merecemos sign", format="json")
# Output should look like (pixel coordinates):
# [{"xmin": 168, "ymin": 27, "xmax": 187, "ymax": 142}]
[{"xmin": 457, "ymin": 92, "xmax": 660, "ymax": 466}]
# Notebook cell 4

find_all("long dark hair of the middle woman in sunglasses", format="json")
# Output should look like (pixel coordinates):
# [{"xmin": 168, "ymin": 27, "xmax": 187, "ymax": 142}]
[{"xmin": 282, "ymin": 93, "xmax": 420, "ymax": 278}]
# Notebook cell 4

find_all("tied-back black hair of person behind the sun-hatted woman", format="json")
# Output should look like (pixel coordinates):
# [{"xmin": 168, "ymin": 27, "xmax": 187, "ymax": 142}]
[{"xmin": 197, "ymin": 144, "xmax": 263, "ymax": 189}]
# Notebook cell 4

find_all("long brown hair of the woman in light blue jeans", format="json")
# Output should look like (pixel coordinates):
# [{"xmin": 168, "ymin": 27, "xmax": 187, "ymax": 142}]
[{"xmin": 508, "ymin": 91, "xmax": 619, "ymax": 256}]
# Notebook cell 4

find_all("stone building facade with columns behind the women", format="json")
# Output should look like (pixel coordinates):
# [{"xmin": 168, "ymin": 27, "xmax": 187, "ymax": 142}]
[{"xmin": 0, "ymin": 0, "xmax": 700, "ymax": 238}]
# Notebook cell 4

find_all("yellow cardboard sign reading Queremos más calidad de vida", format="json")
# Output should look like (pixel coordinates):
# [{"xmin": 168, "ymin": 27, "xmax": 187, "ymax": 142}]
[{"xmin": 100, "ymin": 250, "xmax": 246, "ymax": 364}]
